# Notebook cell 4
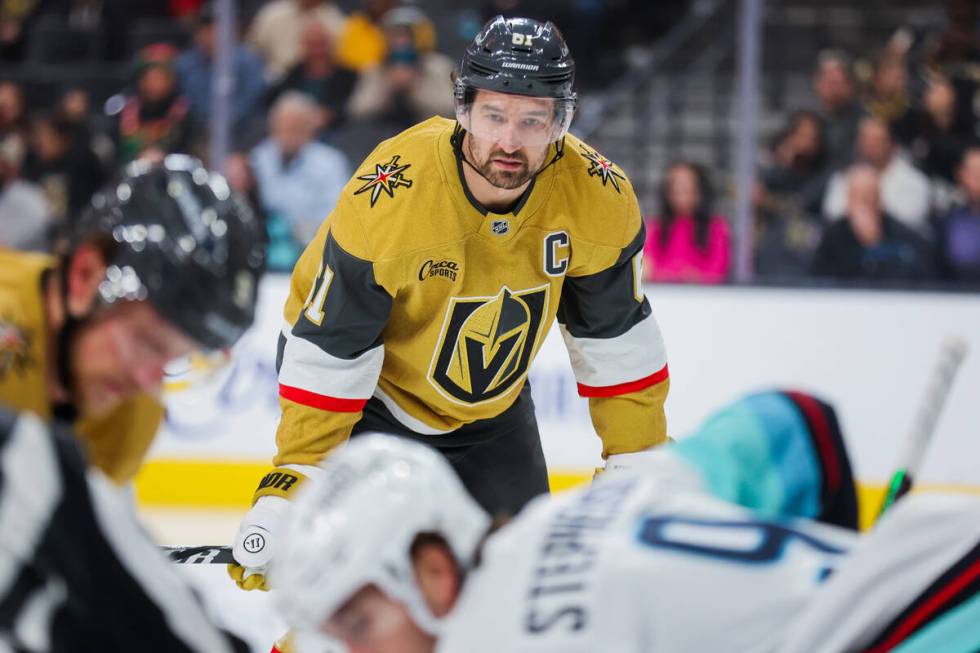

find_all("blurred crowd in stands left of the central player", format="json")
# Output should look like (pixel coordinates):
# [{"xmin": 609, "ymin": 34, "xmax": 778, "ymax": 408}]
[{"xmin": 0, "ymin": 0, "xmax": 472, "ymax": 270}]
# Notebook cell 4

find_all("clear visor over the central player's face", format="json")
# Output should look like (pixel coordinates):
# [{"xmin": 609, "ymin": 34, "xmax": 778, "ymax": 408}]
[{"xmin": 456, "ymin": 91, "xmax": 575, "ymax": 148}]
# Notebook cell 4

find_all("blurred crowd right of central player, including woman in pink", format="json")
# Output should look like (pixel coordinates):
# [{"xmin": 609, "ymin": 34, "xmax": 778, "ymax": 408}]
[{"xmin": 644, "ymin": 0, "xmax": 980, "ymax": 289}]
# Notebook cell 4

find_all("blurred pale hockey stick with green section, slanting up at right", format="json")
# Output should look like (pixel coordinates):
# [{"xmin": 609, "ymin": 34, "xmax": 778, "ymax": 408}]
[{"xmin": 878, "ymin": 337, "xmax": 969, "ymax": 519}]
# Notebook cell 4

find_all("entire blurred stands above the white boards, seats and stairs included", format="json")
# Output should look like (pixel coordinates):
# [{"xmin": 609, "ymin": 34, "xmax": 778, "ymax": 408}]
[{"xmin": 0, "ymin": 0, "xmax": 980, "ymax": 291}]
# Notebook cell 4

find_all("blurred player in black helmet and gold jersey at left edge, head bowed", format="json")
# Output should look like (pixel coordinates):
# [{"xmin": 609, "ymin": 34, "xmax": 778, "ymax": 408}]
[{"xmin": 0, "ymin": 155, "xmax": 265, "ymax": 483}]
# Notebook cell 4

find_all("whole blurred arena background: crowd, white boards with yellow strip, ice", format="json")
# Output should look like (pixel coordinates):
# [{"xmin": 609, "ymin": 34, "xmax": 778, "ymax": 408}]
[{"xmin": 0, "ymin": 0, "xmax": 980, "ymax": 651}]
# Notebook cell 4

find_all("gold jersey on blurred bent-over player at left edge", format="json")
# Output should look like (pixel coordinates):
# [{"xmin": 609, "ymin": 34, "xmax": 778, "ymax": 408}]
[{"xmin": 0, "ymin": 250, "xmax": 163, "ymax": 483}]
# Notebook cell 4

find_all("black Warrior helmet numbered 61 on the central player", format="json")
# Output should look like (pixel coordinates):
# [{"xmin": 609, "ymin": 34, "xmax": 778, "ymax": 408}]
[{"xmin": 455, "ymin": 16, "xmax": 576, "ymax": 142}]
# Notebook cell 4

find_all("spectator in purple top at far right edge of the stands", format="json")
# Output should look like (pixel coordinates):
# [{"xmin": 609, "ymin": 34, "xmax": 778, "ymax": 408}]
[{"xmin": 937, "ymin": 145, "xmax": 980, "ymax": 287}]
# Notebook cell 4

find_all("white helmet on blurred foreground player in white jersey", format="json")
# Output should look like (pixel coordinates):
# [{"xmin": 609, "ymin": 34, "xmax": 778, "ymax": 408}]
[{"xmin": 270, "ymin": 434, "xmax": 490, "ymax": 635}]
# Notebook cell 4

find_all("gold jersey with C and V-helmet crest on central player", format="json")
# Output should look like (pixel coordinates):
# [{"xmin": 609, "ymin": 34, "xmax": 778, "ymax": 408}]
[{"xmin": 274, "ymin": 118, "xmax": 669, "ymax": 465}]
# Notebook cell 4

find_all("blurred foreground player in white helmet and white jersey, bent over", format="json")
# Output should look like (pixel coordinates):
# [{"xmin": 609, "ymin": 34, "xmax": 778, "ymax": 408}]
[{"xmin": 270, "ymin": 393, "xmax": 980, "ymax": 653}]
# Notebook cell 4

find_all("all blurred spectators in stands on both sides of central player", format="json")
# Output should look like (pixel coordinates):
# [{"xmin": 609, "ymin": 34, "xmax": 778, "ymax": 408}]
[{"xmin": 0, "ymin": 0, "xmax": 980, "ymax": 287}]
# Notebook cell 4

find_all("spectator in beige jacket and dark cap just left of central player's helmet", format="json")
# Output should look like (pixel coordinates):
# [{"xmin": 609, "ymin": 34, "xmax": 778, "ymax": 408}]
[{"xmin": 350, "ymin": 7, "xmax": 455, "ymax": 129}]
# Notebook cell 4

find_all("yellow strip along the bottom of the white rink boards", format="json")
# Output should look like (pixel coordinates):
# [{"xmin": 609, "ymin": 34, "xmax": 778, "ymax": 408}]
[{"xmin": 135, "ymin": 459, "xmax": 980, "ymax": 528}]
